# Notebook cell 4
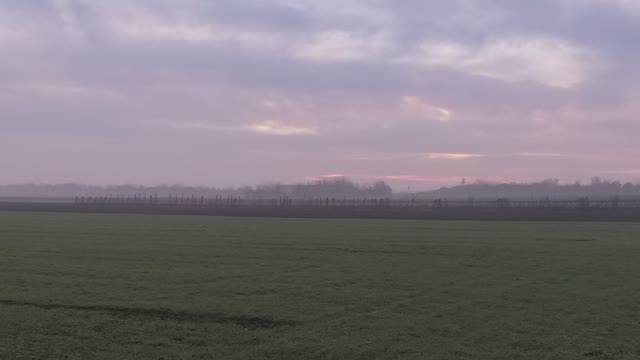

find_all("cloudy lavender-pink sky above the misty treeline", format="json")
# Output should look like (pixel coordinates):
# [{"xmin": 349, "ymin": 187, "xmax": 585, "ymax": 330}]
[{"xmin": 0, "ymin": 0, "xmax": 640, "ymax": 189}]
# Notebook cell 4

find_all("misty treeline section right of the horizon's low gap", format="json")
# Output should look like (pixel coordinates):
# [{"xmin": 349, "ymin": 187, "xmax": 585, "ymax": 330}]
[{"xmin": 424, "ymin": 177, "xmax": 640, "ymax": 199}]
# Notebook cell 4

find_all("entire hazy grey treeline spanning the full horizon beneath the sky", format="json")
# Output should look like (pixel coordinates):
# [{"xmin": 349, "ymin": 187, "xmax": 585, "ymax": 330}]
[{"xmin": 0, "ymin": 177, "xmax": 640, "ymax": 200}]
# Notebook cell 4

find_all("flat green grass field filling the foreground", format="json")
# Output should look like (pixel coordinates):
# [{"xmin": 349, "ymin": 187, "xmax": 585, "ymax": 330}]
[{"xmin": 0, "ymin": 213, "xmax": 640, "ymax": 360}]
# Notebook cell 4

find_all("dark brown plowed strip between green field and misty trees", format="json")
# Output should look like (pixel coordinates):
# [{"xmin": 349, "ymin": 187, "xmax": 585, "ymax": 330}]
[{"xmin": 0, "ymin": 202, "xmax": 640, "ymax": 222}]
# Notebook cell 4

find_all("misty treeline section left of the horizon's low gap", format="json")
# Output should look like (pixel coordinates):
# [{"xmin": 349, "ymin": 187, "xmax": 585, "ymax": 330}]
[{"xmin": 0, "ymin": 179, "xmax": 393, "ymax": 199}]
